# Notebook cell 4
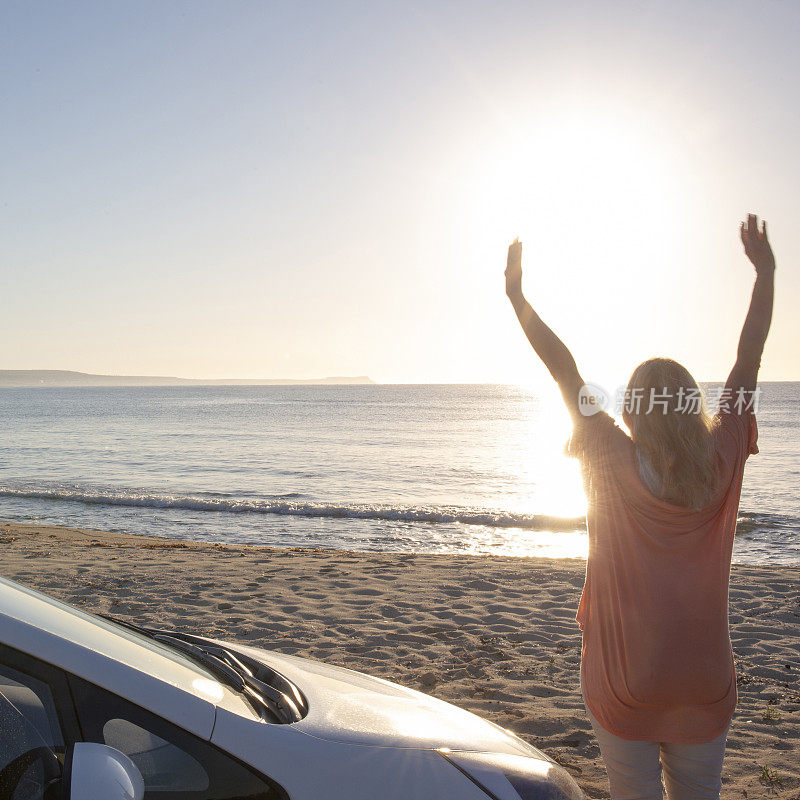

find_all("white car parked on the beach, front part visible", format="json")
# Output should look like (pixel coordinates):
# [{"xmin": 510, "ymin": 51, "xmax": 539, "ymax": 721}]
[{"xmin": 0, "ymin": 578, "xmax": 584, "ymax": 800}]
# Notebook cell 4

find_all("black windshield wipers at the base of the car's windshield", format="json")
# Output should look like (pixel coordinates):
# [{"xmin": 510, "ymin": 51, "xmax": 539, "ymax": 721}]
[{"xmin": 98, "ymin": 614, "xmax": 308, "ymax": 724}]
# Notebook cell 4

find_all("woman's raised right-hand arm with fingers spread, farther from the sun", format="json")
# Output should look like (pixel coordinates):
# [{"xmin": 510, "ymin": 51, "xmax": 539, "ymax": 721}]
[{"xmin": 725, "ymin": 214, "xmax": 775, "ymax": 393}]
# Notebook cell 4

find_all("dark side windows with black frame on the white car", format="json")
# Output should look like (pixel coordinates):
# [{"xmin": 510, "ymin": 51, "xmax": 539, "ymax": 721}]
[{"xmin": 0, "ymin": 645, "xmax": 288, "ymax": 800}]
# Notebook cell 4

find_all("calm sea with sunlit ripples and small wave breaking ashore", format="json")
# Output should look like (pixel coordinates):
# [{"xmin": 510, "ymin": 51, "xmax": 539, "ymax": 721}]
[{"xmin": 0, "ymin": 383, "xmax": 800, "ymax": 564}]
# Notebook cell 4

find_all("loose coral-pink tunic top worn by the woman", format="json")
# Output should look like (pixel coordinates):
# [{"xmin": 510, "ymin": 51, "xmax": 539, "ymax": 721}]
[{"xmin": 570, "ymin": 411, "xmax": 758, "ymax": 744}]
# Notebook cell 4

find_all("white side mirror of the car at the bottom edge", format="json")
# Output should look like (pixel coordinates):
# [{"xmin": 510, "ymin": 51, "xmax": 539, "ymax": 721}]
[{"xmin": 64, "ymin": 742, "xmax": 144, "ymax": 800}]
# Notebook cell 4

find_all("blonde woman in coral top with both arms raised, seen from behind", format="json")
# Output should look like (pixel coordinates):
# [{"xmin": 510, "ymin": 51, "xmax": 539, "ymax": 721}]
[{"xmin": 506, "ymin": 214, "xmax": 775, "ymax": 800}]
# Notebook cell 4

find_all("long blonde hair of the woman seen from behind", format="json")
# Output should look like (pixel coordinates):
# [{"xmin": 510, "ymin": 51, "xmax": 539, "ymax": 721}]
[{"xmin": 623, "ymin": 358, "xmax": 716, "ymax": 510}]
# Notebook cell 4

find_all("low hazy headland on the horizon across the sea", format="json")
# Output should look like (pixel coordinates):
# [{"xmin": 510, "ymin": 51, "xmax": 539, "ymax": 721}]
[{"xmin": 0, "ymin": 369, "xmax": 375, "ymax": 388}]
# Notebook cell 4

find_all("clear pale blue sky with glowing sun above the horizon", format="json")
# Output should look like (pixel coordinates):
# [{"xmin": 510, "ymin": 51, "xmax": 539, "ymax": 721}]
[{"xmin": 0, "ymin": 0, "xmax": 800, "ymax": 386}]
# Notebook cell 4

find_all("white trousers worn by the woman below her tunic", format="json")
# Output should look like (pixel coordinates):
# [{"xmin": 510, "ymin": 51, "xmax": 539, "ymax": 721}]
[{"xmin": 586, "ymin": 707, "xmax": 728, "ymax": 800}]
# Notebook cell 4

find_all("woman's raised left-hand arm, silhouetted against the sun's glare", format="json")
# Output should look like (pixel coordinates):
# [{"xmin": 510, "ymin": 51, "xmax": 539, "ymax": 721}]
[{"xmin": 506, "ymin": 239, "xmax": 583, "ymax": 419}]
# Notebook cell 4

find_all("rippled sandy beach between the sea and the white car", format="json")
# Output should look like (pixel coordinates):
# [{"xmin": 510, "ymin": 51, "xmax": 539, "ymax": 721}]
[{"xmin": 0, "ymin": 523, "xmax": 800, "ymax": 800}]
